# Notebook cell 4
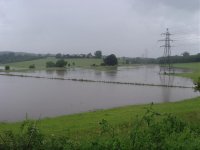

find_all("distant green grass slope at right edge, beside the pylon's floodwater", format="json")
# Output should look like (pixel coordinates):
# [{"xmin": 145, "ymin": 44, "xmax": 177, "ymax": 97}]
[{"xmin": 174, "ymin": 62, "xmax": 200, "ymax": 81}]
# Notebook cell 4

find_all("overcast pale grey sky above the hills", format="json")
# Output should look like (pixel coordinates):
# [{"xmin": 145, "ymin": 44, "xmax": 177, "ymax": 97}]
[{"xmin": 0, "ymin": 0, "xmax": 200, "ymax": 57}]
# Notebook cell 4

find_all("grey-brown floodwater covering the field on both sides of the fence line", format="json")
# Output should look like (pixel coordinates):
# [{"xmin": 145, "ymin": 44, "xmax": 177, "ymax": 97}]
[{"xmin": 0, "ymin": 66, "xmax": 200, "ymax": 121}]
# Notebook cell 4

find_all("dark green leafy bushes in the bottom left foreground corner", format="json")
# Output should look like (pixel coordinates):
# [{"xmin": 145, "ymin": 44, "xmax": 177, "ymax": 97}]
[{"xmin": 0, "ymin": 120, "xmax": 77, "ymax": 150}]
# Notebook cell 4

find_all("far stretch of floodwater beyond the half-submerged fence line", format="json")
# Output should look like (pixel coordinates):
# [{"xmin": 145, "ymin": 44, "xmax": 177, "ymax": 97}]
[{"xmin": 18, "ymin": 65, "xmax": 193, "ymax": 86}]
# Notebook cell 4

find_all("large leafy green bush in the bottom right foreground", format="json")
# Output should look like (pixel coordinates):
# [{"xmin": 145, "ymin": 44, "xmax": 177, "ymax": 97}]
[{"xmin": 130, "ymin": 106, "xmax": 200, "ymax": 150}]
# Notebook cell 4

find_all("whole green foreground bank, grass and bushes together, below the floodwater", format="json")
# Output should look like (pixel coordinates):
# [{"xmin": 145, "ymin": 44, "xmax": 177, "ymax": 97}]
[{"xmin": 0, "ymin": 97, "xmax": 200, "ymax": 150}]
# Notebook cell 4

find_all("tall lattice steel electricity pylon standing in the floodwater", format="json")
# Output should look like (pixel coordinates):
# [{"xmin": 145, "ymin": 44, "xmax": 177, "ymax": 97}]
[{"xmin": 159, "ymin": 28, "xmax": 174, "ymax": 74}]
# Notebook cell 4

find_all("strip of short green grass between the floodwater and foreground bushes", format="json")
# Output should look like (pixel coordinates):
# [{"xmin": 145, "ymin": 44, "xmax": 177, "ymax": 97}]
[{"xmin": 0, "ymin": 97, "xmax": 200, "ymax": 139}]
